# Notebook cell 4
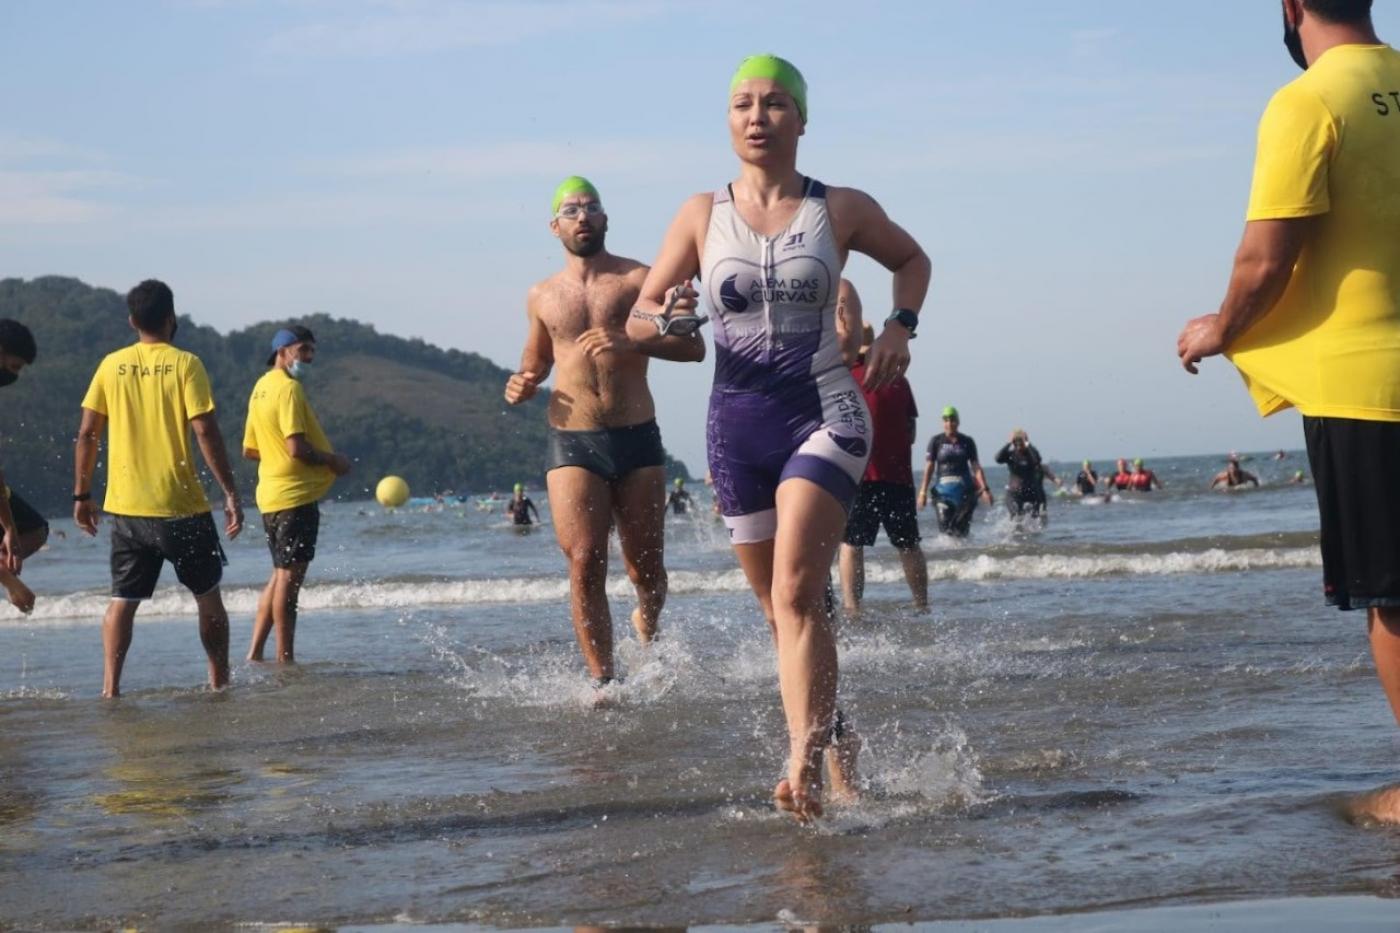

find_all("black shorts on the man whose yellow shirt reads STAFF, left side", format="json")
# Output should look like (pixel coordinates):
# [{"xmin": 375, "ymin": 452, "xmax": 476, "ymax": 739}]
[{"xmin": 112, "ymin": 511, "xmax": 228, "ymax": 600}]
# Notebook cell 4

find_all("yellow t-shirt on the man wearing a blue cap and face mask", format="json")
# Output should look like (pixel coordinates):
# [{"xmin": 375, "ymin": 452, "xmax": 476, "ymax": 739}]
[{"xmin": 244, "ymin": 367, "xmax": 336, "ymax": 513}]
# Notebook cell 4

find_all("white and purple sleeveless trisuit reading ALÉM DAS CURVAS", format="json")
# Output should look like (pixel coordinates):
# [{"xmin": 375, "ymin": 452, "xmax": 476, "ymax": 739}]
[{"xmin": 700, "ymin": 178, "xmax": 871, "ymax": 544}]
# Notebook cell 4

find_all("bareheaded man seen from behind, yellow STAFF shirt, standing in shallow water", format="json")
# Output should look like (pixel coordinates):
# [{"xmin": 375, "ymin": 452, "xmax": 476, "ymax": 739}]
[{"xmin": 73, "ymin": 279, "xmax": 244, "ymax": 696}]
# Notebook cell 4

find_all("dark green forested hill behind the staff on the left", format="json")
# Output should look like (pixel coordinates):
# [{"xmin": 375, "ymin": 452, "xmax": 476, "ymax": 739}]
[{"xmin": 0, "ymin": 276, "xmax": 683, "ymax": 514}]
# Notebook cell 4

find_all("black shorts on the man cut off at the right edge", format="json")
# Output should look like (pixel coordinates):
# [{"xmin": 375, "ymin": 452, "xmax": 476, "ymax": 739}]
[{"xmin": 1303, "ymin": 417, "xmax": 1400, "ymax": 609}]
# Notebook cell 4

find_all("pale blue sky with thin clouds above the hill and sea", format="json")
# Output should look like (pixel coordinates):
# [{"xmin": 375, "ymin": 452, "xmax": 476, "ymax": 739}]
[{"xmin": 0, "ymin": 0, "xmax": 1400, "ymax": 469}]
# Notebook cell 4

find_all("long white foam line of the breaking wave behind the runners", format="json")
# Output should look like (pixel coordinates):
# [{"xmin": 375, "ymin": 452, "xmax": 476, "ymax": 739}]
[{"xmin": 0, "ymin": 548, "xmax": 1322, "ymax": 625}]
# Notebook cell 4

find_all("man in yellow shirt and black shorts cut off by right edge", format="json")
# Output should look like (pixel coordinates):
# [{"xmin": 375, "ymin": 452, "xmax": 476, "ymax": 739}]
[{"xmin": 1177, "ymin": 0, "xmax": 1400, "ymax": 821}]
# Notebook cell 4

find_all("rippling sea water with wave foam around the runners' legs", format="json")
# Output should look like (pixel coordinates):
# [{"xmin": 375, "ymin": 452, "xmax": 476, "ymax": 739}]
[{"xmin": 0, "ymin": 452, "xmax": 1400, "ymax": 929}]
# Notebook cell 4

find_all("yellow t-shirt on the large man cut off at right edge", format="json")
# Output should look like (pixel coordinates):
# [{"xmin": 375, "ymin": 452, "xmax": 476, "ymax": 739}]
[{"xmin": 1228, "ymin": 45, "xmax": 1400, "ymax": 422}]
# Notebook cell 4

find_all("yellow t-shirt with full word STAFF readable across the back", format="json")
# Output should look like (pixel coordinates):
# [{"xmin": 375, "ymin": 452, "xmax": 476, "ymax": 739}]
[{"xmin": 83, "ymin": 343, "xmax": 214, "ymax": 518}]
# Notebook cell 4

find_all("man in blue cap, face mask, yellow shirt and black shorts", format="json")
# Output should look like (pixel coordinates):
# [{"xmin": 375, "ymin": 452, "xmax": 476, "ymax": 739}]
[{"xmin": 244, "ymin": 325, "xmax": 350, "ymax": 663}]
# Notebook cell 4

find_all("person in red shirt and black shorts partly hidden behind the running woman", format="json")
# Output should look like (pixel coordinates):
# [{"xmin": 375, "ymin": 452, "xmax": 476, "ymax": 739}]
[{"xmin": 840, "ymin": 312, "xmax": 928, "ymax": 619}]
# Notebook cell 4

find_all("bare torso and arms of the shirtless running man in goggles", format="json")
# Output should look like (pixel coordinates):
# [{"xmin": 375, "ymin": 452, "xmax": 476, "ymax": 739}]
[{"xmin": 505, "ymin": 256, "xmax": 655, "ymax": 430}]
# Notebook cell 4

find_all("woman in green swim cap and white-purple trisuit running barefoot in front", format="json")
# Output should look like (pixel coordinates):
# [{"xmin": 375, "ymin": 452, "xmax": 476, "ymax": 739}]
[{"xmin": 627, "ymin": 55, "xmax": 928, "ymax": 821}]
